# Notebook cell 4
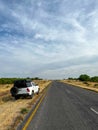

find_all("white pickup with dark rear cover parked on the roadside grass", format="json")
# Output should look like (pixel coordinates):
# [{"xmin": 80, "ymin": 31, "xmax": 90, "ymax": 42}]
[{"xmin": 10, "ymin": 79, "xmax": 40, "ymax": 99}]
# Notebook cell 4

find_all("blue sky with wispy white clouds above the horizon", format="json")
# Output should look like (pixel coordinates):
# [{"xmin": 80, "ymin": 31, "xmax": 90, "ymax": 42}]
[{"xmin": 0, "ymin": 0, "xmax": 98, "ymax": 79}]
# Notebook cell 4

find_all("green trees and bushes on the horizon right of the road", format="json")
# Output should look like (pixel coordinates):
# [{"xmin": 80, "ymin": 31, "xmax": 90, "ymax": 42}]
[{"xmin": 68, "ymin": 74, "xmax": 98, "ymax": 82}]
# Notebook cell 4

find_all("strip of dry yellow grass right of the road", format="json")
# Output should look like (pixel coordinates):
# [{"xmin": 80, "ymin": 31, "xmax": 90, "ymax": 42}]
[{"xmin": 62, "ymin": 80, "xmax": 98, "ymax": 92}]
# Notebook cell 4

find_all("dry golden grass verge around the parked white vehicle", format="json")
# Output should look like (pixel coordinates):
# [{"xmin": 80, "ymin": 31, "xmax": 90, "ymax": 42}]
[{"xmin": 0, "ymin": 80, "xmax": 51, "ymax": 130}]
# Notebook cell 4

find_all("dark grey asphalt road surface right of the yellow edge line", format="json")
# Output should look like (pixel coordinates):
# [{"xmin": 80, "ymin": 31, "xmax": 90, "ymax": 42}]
[{"xmin": 21, "ymin": 81, "xmax": 98, "ymax": 130}]
